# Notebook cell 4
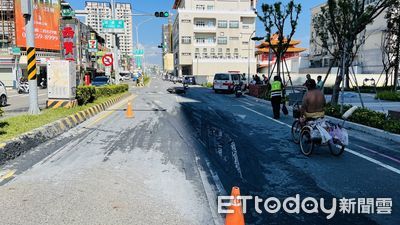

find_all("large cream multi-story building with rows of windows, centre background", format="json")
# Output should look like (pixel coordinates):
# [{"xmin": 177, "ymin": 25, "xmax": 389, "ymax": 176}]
[{"xmin": 172, "ymin": 0, "xmax": 256, "ymax": 83}]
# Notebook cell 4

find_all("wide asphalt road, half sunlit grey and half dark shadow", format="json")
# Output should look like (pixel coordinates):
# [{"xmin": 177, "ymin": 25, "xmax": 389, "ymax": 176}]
[{"xmin": 0, "ymin": 76, "xmax": 400, "ymax": 225}]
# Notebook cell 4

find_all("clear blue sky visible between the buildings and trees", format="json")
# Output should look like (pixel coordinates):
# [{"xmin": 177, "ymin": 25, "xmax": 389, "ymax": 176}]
[{"xmin": 67, "ymin": 0, "xmax": 326, "ymax": 64}]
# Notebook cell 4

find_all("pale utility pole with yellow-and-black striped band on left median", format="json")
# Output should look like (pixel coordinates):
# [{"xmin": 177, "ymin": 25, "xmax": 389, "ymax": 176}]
[{"xmin": 21, "ymin": 0, "xmax": 40, "ymax": 115}]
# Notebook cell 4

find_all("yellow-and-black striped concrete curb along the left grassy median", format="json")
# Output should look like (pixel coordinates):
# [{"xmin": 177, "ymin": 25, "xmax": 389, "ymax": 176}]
[{"xmin": 0, "ymin": 93, "xmax": 131, "ymax": 165}]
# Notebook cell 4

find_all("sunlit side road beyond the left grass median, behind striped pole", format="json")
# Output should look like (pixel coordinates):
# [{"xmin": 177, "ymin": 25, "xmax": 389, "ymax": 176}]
[{"xmin": 3, "ymin": 88, "xmax": 47, "ymax": 117}]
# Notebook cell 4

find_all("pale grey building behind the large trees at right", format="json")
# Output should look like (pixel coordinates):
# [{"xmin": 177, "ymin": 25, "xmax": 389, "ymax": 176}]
[{"xmin": 309, "ymin": 1, "xmax": 386, "ymax": 74}]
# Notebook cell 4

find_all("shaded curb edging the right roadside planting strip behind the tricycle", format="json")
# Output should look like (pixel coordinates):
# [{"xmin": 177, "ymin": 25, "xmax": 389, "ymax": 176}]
[{"xmin": 242, "ymin": 95, "xmax": 400, "ymax": 143}]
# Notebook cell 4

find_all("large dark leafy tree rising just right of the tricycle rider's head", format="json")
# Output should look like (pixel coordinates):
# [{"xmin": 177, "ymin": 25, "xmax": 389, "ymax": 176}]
[{"xmin": 313, "ymin": 0, "xmax": 393, "ymax": 105}]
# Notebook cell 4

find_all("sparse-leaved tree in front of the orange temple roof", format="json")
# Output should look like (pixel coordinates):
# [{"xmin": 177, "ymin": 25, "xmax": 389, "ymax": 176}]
[{"xmin": 257, "ymin": 0, "xmax": 301, "ymax": 80}]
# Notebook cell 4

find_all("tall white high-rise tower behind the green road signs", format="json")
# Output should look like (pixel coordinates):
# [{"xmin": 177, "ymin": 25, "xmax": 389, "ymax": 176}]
[{"xmin": 85, "ymin": 1, "xmax": 133, "ymax": 56}]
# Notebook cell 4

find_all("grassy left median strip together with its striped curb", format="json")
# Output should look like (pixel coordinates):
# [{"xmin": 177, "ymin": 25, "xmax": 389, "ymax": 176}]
[{"xmin": 0, "ymin": 93, "xmax": 131, "ymax": 164}]
